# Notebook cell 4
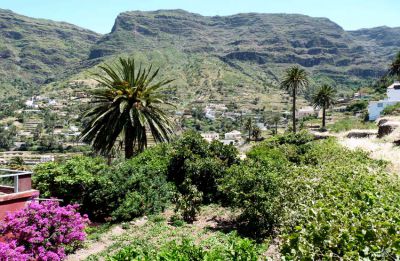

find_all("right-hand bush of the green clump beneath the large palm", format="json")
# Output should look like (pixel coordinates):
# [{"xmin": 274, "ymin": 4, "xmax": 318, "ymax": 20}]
[{"xmin": 106, "ymin": 146, "xmax": 175, "ymax": 221}]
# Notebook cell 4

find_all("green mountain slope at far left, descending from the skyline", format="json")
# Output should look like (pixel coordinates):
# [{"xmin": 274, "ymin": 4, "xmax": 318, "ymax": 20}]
[{"xmin": 0, "ymin": 9, "xmax": 100, "ymax": 96}]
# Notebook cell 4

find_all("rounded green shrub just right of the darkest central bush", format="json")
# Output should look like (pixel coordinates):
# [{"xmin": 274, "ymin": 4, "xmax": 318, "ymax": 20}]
[{"xmin": 220, "ymin": 160, "xmax": 281, "ymax": 238}]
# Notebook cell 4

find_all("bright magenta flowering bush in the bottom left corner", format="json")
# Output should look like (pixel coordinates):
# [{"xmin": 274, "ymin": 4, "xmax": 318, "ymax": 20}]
[{"xmin": 0, "ymin": 201, "xmax": 89, "ymax": 260}]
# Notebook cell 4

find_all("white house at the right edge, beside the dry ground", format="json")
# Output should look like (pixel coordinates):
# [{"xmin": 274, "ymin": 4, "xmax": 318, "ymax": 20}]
[{"xmin": 368, "ymin": 81, "xmax": 400, "ymax": 121}]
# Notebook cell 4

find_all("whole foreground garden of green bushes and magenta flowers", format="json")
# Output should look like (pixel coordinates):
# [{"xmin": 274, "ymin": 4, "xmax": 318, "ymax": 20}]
[{"xmin": 0, "ymin": 131, "xmax": 400, "ymax": 260}]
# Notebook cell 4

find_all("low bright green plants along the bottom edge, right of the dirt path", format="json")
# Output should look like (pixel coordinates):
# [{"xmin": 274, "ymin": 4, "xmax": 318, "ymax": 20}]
[{"xmin": 107, "ymin": 233, "xmax": 261, "ymax": 261}]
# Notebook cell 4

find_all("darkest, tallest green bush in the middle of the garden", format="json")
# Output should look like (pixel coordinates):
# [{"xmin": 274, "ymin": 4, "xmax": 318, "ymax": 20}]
[{"xmin": 168, "ymin": 132, "xmax": 238, "ymax": 222}]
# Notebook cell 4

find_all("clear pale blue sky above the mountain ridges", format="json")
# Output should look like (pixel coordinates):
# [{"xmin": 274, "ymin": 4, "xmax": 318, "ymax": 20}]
[{"xmin": 0, "ymin": 0, "xmax": 400, "ymax": 33}]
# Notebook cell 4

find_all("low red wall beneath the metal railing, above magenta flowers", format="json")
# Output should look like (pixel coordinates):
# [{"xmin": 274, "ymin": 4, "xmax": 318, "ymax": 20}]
[{"xmin": 0, "ymin": 189, "xmax": 39, "ymax": 220}]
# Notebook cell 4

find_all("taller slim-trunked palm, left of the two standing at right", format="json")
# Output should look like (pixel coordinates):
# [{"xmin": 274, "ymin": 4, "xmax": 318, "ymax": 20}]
[{"xmin": 280, "ymin": 65, "xmax": 309, "ymax": 132}]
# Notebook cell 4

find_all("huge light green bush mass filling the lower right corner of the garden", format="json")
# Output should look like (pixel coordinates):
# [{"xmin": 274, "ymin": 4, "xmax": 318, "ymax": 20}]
[{"xmin": 221, "ymin": 134, "xmax": 400, "ymax": 260}]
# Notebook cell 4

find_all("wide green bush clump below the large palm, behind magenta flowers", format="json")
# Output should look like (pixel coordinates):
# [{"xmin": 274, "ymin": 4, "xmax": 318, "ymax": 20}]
[{"xmin": 33, "ymin": 145, "xmax": 174, "ymax": 221}]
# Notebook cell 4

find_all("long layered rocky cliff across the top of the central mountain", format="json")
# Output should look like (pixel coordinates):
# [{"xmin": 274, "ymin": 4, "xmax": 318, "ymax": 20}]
[{"xmin": 90, "ymin": 10, "xmax": 400, "ymax": 85}]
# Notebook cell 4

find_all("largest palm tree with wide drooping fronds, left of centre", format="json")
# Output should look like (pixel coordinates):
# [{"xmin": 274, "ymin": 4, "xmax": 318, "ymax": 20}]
[{"xmin": 81, "ymin": 58, "xmax": 173, "ymax": 159}]
